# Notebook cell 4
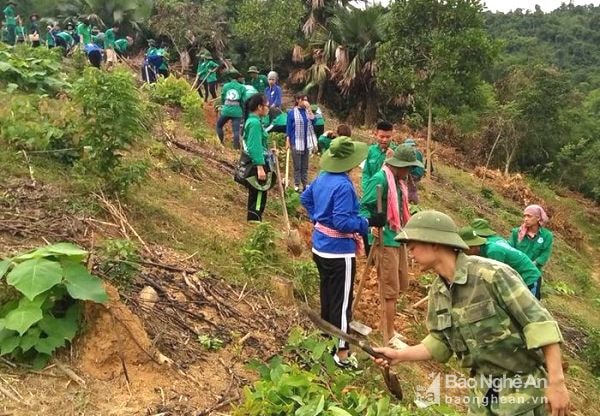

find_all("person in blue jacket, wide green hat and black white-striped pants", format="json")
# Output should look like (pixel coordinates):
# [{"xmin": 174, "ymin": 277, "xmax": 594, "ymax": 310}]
[{"xmin": 300, "ymin": 136, "xmax": 385, "ymax": 367}]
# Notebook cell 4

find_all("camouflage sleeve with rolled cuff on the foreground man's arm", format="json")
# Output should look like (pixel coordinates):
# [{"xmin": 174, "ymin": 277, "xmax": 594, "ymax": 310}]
[{"xmin": 482, "ymin": 267, "xmax": 563, "ymax": 349}]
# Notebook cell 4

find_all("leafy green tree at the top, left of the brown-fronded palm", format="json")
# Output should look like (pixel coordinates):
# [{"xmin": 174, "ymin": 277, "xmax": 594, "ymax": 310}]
[{"xmin": 233, "ymin": 0, "xmax": 304, "ymax": 69}]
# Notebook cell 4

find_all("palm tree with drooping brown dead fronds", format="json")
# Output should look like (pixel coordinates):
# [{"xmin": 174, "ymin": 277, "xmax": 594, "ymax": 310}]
[{"xmin": 307, "ymin": 6, "xmax": 386, "ymax": 123}]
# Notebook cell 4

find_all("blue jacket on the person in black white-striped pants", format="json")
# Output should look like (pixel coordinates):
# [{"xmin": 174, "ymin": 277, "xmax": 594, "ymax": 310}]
[{"xmin": 300, "ymin": 172, "xmax": 369, "ymax": 258}]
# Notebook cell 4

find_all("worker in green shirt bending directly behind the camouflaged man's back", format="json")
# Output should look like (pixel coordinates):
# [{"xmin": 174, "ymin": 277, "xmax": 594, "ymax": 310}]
[{"xmin": 459, "ymin": 226, "xmax": 542, "ymax": 295}]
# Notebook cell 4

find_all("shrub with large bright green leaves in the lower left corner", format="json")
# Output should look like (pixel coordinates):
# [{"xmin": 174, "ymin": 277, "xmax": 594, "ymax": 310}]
[{"xmin": 0, "ymin": 243, "xmax": 108, "ymax": 367}]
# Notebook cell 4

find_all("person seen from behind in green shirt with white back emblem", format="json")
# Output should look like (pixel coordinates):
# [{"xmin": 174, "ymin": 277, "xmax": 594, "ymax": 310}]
[{"xmin": 216, "ymin": 69, "xmax": 246, "ymax": 149}]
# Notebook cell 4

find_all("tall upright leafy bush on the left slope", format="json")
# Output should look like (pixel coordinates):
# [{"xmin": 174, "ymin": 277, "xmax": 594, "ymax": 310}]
[{"xmin": 73, "ymin": 68, "xmax": 149, "ymax": 193}]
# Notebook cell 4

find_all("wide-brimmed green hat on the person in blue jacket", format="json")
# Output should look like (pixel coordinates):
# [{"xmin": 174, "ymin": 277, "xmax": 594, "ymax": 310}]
[{"xmin": 320, "ymin": 136, "xmax": 369, "ymax": 173}]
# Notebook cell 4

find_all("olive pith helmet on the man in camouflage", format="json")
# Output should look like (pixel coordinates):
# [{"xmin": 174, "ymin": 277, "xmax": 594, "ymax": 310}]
[{"xmin": 396, "ymin": 210, "xmax": 469, "ymax": 250}]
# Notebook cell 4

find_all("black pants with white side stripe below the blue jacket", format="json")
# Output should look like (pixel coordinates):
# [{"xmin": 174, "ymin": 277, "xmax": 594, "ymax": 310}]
[{"xmin": 313, "ymin": 253, "xmax": 356, "ymax": 350}]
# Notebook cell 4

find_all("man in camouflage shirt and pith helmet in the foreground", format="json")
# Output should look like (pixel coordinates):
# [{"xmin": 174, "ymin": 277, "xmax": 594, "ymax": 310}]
[{"xmin": 375, "ymin": 211, "xmax": 569, "ymax": 416}]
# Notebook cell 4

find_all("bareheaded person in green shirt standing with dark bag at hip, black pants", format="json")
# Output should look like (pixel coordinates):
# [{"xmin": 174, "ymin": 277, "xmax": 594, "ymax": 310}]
[{"xmin": 243, "ymin": 94, "xmax": 275, "ymax": 221}]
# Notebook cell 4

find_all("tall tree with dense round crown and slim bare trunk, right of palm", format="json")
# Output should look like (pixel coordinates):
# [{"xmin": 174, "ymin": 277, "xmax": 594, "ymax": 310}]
[{"xmin": 378, "ymin": 0, "xmax": 496, "ymax": 174}]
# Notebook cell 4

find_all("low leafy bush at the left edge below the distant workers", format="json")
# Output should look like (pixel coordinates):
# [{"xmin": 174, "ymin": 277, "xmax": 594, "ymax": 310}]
[{"xmin": 0, "ymin": 43, "xmax": 69, "ymax": 94}]
